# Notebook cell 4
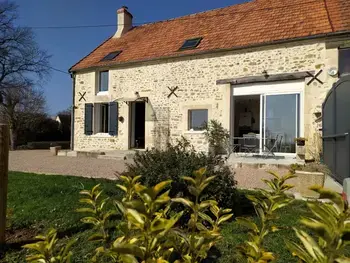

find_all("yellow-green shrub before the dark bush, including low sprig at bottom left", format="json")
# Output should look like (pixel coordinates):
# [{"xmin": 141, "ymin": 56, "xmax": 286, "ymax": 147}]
[{"xmin": 24, "ymin": 168, "xmax": 232, "ymax": 263}]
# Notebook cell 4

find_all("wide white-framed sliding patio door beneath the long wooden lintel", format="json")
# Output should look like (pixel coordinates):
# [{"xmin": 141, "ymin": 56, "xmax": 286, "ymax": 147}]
[{"xmin": 231, "ymin": 80, "xmax": 305, "ymax": 156}]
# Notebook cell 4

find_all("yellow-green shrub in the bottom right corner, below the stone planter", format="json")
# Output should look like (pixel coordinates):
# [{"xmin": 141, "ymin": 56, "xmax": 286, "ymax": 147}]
[{"xmin": 286, "ymin": 187, "xmax": 350, "ymax": 263}]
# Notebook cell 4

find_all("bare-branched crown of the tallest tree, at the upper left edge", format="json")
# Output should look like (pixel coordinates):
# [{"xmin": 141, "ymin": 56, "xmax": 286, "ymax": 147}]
[{"xmin": 0, "ymin": 1, "xmax": 50, "ymax": 121}]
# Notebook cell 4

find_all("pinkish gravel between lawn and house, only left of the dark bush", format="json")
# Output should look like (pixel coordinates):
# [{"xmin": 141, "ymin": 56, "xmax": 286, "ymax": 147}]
[{"xmin": 9, "ymin": 150, "xmax": 125, "ymax": 179}]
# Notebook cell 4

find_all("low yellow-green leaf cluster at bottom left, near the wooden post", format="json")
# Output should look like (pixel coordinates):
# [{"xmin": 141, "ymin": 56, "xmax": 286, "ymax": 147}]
[{"xmin": 23, "ymin": 229, "xmax": 77, "ymax": 263}]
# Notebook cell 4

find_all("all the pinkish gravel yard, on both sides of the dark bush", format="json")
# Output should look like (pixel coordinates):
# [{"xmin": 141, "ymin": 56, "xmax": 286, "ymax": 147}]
[{"xmin": 9, "ymin": 150, "xmax": 292, "ymax": 189}]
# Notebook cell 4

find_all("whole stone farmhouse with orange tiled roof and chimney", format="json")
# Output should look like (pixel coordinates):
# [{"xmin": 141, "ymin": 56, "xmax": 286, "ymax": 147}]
[{"xmin": 70, "ymin": 0, "xmax": 350, "ymax": 161}]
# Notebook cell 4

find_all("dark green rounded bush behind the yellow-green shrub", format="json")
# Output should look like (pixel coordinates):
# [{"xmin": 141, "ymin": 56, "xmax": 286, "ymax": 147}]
[{"xmin": 122, "ymin": 138, "xmax": 239, "ymax": 213}]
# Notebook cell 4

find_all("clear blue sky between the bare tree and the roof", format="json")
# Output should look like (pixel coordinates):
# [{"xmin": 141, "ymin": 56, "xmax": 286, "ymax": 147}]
[{"xmin": 15, "ymin": 0, "xmax": 243, "ymax": 114}]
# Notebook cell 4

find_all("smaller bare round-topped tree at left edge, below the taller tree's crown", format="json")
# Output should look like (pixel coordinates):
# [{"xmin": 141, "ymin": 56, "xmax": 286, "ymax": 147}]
[{"xmin": 1, "ymin": 83, "xmax": 46, "ymax": 150}]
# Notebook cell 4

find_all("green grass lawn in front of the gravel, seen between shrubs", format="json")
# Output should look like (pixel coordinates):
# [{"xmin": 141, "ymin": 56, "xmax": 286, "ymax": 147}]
[{"xmin": 0, "ymin": 172, "xmax": 307, "ymax": 263}]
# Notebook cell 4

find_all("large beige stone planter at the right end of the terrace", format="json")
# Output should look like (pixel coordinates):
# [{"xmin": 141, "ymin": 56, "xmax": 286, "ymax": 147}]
[{"xmin": 294, "ymin": 170, "xmax": 325, "ymax": 198}]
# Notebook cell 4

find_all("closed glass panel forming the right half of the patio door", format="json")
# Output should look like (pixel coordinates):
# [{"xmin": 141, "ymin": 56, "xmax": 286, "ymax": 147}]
[{"xmin": 260, "ymin": 94, "xmax": 300, "ymax": 154}]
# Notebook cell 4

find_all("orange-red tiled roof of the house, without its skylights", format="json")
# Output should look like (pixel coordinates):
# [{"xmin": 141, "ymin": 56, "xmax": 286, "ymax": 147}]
[{"xmin": 71, "ymin": 0, "xmax": 350, "ymax": 71}]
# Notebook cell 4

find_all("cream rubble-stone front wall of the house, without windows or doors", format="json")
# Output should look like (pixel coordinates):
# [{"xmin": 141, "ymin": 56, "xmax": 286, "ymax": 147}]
[{"xmin": 74, "ymin": 39, "xmax": 343, "ymax": 159}]
